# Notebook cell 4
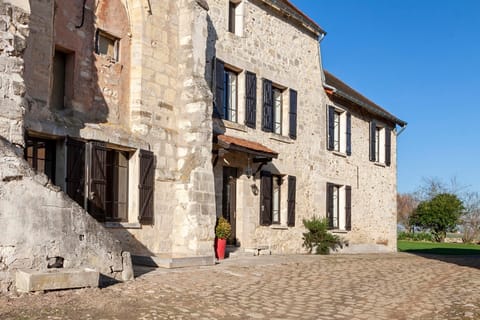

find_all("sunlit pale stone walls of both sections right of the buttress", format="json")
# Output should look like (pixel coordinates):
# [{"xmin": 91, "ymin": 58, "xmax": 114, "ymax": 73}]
[{"xmin": 209, "ymin": 0, "xmax": 396, "ymax": 252}]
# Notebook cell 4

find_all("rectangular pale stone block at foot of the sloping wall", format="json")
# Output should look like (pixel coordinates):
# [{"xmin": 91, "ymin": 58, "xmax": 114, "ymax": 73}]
[{"xmin": 15, "ymin": 268, "xmax": 100, "ymax": 292}]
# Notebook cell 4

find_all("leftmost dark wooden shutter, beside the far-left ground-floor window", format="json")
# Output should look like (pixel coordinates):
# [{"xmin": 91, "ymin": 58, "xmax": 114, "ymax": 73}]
[{"xmin": 65, "ymin": 138, "xmax": 85, "ymax": 207}]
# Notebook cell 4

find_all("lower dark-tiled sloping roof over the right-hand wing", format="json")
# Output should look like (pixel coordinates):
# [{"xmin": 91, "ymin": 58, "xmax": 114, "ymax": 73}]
[{"xmin": 324, "ymin": 70, "xmax": 407, "ymax": 127}]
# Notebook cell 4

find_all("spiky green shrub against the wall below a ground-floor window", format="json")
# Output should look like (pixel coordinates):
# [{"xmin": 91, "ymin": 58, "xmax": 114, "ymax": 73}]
[{"xmin": 303, "ymin": 216, "xmax": 347, "ymax": 254}]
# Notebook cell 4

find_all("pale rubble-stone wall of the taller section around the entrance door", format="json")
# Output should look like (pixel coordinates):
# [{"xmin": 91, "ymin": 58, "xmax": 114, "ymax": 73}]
[{"xmin": 209, "ymin": 0, "xmax": 326, "ymax": 253}]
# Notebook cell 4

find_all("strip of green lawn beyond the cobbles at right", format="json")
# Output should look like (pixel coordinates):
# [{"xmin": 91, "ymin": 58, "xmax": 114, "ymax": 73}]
[{"xmin": 397, "ymin": 240, "xmax": 480, "ymax": 255}]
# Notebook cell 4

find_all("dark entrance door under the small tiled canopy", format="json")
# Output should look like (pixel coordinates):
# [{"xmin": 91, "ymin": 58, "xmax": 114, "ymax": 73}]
[{"xmin": 222, "ymin": 167, "xmax": 237, "ymax": 245}]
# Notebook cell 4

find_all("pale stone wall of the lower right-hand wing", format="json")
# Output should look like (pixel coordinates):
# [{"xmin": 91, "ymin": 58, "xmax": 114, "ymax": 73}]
[{"xmin": 320, "ymin": 102, "xmax": 397, "ymax": 252}]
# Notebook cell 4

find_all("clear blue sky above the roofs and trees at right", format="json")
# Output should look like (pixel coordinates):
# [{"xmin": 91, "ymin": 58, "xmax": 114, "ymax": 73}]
[{"xmin": 291, "ymin": 0, "xmax": 480, "ymax": 192}]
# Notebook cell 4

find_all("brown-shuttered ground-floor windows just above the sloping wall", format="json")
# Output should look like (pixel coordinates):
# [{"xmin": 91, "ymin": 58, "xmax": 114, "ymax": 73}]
[{"xmin": 24, "ymin": 136, "xmax": 155, "ymax": 223}]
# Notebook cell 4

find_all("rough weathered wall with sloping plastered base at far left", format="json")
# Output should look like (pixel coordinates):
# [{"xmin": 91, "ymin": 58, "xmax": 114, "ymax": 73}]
[{"xmin": 0, "ymin": 1, "xmax": 133, "ymax": 291}]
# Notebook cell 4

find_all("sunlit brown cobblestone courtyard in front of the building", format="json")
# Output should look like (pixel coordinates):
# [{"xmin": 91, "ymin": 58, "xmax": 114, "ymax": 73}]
[{"xmin": 0, "ymin": 254, "xmax": 480, "ymax": 320}]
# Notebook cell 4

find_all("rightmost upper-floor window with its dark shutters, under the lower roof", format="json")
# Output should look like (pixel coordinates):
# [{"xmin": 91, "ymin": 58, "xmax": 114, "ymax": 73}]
[{"xmin": 370, "ymin": 121, "xmax": 392, "ymax": 166}]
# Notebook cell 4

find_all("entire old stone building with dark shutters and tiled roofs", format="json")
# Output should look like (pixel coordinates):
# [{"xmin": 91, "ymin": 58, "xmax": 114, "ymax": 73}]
[{"xmin": 0, "ymin": 0, "xmax": 405, "ymax": 290}]
